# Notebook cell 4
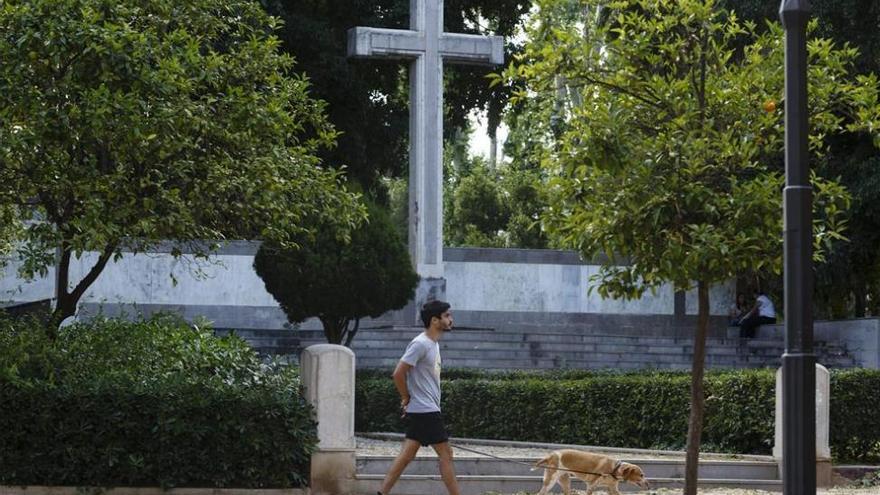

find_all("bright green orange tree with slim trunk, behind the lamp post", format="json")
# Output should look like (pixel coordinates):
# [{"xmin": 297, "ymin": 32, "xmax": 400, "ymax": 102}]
[{"xmin": 499, "ymin": 0, "xmax": 880, "ymax": 495}]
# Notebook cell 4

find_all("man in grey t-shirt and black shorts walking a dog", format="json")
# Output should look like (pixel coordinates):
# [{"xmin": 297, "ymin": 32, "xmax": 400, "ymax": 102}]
[{"xmin": 378, "ymin": 301, "xmax": 459, "ymax": 495}]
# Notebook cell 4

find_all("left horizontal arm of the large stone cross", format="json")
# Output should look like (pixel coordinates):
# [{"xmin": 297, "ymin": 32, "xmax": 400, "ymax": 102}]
[{"xmin": 348, "ymin": 27, "xmax": 425, "ymax": 59}]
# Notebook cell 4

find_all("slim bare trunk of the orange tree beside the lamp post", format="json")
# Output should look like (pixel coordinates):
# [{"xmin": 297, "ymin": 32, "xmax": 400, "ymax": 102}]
[{"xmin": 684, "ymin": 281, "xmax": 709, "ymax": 495}]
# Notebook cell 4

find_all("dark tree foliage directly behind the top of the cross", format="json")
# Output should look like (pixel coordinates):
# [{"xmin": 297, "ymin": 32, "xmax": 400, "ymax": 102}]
[{"xmin": 264, "ymin": 0, "xmax": 531, "ymax": 190}]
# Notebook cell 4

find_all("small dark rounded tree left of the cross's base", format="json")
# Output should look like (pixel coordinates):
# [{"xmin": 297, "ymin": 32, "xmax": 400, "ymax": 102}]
[{"xmin": 254, "ymin": 201, "xmax": 419, "ymax": 346}]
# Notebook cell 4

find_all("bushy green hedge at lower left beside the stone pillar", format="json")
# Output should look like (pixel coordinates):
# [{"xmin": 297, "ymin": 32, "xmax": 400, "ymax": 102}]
[{"xmin": 0, "ymin": 317, "xmax": 317, "ymax": 488}]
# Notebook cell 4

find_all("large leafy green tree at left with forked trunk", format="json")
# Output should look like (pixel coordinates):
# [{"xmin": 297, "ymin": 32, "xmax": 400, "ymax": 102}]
[{"xmin": 0, "ymin": 0, "xmax": 363, "ymax": 333}]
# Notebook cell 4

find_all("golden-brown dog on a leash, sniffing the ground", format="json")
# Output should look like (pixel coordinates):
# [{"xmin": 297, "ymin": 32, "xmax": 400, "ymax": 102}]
[{"xmin": 534, "ymin": 449, "xmax": 648, "ymax": 495}]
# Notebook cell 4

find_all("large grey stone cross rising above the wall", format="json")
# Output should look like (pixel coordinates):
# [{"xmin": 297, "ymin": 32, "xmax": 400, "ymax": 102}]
[{"xmin": 348, "ymin": 0, "xmax": 504, "ymax": 279}]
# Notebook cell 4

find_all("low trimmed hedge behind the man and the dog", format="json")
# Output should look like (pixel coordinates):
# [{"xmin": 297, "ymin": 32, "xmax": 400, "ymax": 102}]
[{"xmin": 355, "ymin": 370, "xmax": 880, "ymax": 461}]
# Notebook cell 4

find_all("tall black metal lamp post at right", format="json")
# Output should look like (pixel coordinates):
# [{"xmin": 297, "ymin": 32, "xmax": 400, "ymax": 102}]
[{"xmin": 779, "ymin": 0, "xmax": 816, "ymax": 495}]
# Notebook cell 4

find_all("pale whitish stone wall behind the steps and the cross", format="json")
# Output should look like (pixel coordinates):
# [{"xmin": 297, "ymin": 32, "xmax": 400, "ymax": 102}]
[{"xmin": 0, "ymin": 242, "xmax": 733, "ymax": 328}]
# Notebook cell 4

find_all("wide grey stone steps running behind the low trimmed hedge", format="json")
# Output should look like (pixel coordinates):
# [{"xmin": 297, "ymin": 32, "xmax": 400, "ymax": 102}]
[{"xmin": 217, "ymin": 326, "xmax": 858, "ymax": 369}]
